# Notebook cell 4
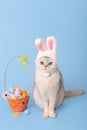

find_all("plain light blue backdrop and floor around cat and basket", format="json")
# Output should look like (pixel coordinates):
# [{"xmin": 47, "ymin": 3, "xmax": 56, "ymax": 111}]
[{"xmin": 0, "ymin": 0, "xmax": 87, "ymax": 130}]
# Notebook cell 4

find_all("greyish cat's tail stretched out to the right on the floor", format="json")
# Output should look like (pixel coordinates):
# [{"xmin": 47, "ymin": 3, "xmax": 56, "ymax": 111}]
[{"xmin": 65, "ymin": 89, "xmax": 85, "ymax": 98}]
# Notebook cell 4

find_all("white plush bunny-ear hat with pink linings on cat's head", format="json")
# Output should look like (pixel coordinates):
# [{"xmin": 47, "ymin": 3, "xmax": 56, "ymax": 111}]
[{"xmin": 35, "ymin": 36, "xmax": 57, "ymax": 60}]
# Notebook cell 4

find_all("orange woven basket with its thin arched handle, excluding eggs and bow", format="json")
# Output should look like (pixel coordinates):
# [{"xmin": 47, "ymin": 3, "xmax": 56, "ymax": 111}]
[{"xmin": 4, "ymin": 56, "xmax": 30, "ymax": 112}]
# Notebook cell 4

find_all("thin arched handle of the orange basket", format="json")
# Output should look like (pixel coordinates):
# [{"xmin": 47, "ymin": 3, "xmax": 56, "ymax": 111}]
[{"xmin": 4, "ymin": 56, "xmax": 32, "ymax": 90}]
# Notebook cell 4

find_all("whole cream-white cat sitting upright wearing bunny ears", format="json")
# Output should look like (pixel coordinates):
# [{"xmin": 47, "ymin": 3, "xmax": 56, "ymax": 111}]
[{"xmin": 33, "ymin": 37, "xmax": 84, "ymax": 117}]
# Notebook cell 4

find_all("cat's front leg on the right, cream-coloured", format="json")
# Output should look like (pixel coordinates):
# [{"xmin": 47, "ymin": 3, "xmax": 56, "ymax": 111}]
[{"xmin": 49, "ymin": 97, "xmax": 56, "ymax": 118}]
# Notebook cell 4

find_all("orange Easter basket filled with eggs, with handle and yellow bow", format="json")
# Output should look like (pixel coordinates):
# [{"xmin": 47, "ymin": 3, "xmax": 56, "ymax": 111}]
[{"xmin": 3, "ymin": 54, "xmax": 30, "ymax": 112}]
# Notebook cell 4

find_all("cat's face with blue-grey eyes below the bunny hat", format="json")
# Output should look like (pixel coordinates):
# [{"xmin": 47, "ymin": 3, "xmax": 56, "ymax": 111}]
[{"xmin": 36, "ymin": 56, "xmax": 57, "ymax": 72}]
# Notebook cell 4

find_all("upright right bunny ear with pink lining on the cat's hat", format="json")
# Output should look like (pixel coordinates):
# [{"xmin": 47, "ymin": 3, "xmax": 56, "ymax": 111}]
[{"xmin": 46, "ymin": 36, "xmax": 57, "ymax": 51}]
